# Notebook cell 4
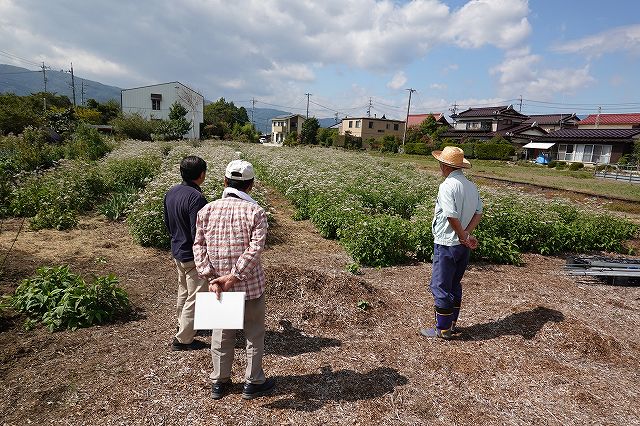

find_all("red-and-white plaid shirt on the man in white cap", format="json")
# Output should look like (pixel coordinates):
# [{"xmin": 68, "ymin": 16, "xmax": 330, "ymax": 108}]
[{"xmin": 193, "ymin": 197, "xmax": 268, "ymax": 300}]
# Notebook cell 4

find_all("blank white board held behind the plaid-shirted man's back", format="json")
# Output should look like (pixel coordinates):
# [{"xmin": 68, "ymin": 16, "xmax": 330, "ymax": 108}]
[{"xmin": 193, "ymin": 291, "xmax": 245, "ymax": 330}]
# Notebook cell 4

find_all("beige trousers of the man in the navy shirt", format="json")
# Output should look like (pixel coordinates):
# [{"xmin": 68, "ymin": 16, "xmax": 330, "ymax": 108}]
[{"xmin": 174, "ymin": 259, "xmax": 209, "ymax": 344}]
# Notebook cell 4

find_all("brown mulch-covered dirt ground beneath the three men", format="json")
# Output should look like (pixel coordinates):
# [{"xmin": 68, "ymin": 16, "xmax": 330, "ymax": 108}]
[{"xmin": 0, "ymin": 194, "xmax": 640, "ymax": 425}]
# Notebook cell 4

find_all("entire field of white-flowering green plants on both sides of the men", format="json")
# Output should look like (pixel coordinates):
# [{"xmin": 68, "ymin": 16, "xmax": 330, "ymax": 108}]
[{"xmin": 2, "ymin": 141, "xmax": 639, "ymax": 266}]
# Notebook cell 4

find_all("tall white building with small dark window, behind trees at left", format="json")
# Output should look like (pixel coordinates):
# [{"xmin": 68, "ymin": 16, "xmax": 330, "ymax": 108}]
[{"xmin": 120, "ymin": 81, "xmax": 204, "ymax": 139}]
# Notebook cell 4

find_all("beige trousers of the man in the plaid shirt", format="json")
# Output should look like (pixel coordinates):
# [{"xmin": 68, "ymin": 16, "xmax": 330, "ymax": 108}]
[{"xmin": 209, "ymin": 293, "xmax": 266, "ymax": 384}]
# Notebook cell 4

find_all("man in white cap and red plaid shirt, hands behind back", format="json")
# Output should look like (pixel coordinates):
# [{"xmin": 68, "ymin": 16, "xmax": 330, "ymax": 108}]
[{"xmin": 193, "ymin": 160, "xmax": 275, "ymax": 399}]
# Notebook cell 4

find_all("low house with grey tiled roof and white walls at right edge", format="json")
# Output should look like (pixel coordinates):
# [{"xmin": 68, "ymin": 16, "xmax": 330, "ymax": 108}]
[{"xmin": 541, "ymin": 128, "xmax": 640, "ymax": 164}]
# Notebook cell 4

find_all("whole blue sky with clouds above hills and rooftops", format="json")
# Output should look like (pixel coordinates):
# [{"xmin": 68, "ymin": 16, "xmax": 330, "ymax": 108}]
[{"xmin": 0, "ymin": 0, "xmax": 640, "ymax": 119}]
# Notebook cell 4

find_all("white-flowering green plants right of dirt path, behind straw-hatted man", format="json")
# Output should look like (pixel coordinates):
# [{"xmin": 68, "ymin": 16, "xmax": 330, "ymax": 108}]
[{"xmin": 238, "ymin": 146, "xmax": 638, "ymax": 266}]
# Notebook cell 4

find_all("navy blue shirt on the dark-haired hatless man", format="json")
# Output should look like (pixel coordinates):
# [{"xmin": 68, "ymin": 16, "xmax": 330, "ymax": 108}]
[{"xmin": 164, "ymin": 181, "xmax": 207, "ymax": 262}]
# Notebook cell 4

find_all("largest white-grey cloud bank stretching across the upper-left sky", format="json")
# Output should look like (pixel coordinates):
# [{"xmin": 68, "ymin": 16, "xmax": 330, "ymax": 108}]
[{"xmin": 0, "ymin": 0, "xmax": 531, "ymax": 99}]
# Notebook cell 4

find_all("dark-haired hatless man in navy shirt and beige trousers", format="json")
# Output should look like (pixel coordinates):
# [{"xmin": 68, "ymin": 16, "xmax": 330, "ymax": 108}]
[{"xmin": 164, "ymin": 156, "xmax": 208, "ymax": 351}]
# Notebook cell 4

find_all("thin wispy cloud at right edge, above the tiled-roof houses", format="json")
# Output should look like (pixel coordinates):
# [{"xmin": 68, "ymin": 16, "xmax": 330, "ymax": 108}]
[{"xmin": 553, "ymin": 24, "xmax": 640, "ymax": 56}]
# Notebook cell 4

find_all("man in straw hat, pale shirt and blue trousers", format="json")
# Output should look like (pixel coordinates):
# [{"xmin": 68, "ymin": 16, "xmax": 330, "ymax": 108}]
[{"xmin": 420, "ymin": 146, "xmax": 482, "ymax": 340}]
